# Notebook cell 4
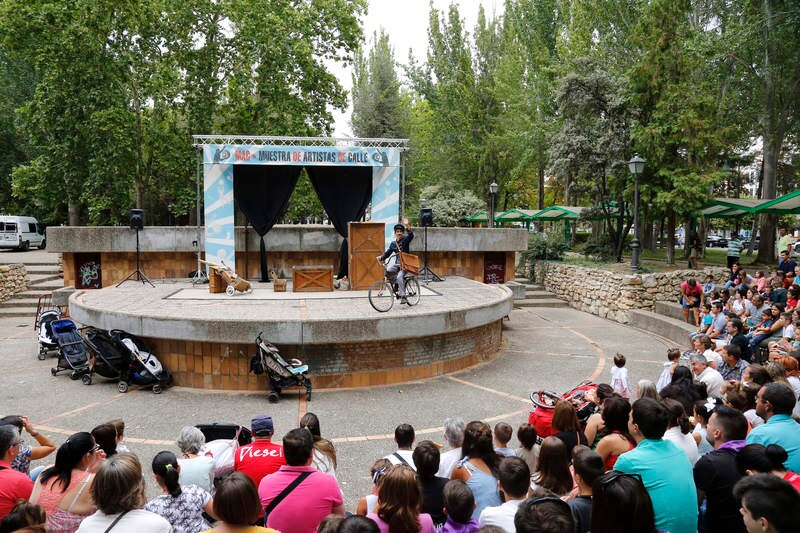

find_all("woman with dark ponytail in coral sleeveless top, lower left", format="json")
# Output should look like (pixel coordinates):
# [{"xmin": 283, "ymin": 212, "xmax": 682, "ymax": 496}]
[{"xmin": 30, "ymin": 431, "xmax": 105, "ymax": 533}]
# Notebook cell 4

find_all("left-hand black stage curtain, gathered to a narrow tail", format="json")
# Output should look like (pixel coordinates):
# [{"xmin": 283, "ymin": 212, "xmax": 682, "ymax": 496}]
[{"xmin": 238, "ymin": 165, "xmax": 301, "ymax": 281}]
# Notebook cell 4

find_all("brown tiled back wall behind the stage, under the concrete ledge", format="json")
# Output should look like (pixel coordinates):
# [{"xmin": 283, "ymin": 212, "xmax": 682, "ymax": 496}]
[{"xmin": 62, "ymin": 250, "xmax": 515, "ymax": 287}]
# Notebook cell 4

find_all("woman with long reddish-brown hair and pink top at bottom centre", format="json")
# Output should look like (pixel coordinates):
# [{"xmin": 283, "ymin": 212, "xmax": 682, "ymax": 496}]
[{"xmin": 367, "ymin": 465, "xmax": 435, "ymax": 533}]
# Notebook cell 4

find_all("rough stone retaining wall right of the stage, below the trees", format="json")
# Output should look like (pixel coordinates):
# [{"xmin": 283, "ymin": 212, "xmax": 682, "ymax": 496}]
[{"xmin": 535, "ymin": 261, "xmax": 728, "ymax": 324}]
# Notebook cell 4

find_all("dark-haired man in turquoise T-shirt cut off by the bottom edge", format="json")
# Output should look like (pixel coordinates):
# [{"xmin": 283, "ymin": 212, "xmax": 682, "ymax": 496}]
[{"xmin": 614, "ymin": 398, "xmax": 697, "ymax": 533}]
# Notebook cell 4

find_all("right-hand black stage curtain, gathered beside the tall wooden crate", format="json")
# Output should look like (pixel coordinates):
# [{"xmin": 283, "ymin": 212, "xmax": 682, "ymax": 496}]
[{"xmin": 306, "ymin": 166, "xmax": 372, "ymax": 278}]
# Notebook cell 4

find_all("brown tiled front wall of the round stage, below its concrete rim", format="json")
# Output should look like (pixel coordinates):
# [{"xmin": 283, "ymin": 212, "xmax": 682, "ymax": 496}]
[{"xmin": 148, "ymin": 320, "xmax": 502, "ymax": 391}]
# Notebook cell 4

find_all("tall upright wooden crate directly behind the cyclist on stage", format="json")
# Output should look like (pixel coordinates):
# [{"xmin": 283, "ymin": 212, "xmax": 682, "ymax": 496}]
[{"xmin": 347, "ymin": 222, "xmax": 386, "ymax": 290}]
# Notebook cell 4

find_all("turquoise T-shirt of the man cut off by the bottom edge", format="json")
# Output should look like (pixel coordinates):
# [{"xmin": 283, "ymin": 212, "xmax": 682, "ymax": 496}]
[{"xmin": 614, "ymin": 439, "xmax": 697, "ymax": 533}]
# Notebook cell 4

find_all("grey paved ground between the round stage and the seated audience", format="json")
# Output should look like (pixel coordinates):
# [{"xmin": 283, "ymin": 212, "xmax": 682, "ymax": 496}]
[{"xmin": 0, "ymin": 298, "xmax": 671, "ymax": 510}]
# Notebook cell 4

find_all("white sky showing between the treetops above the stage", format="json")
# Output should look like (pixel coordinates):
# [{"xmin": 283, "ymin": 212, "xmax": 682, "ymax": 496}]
[{"xmin": 330, "ymin": 0, "xmax": 503, "ymax": 137}]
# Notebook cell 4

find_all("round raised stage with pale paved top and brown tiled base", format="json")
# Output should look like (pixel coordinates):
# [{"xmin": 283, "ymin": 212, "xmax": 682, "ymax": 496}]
[{"xmin": 69, "ymin": 277, "xmax": 512, "ymax": 390}]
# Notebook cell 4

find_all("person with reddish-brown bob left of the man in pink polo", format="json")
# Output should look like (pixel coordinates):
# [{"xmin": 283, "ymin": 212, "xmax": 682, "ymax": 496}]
[{"xmin": 205, "ymin": 472, "xmax": 280, "ymax": 533}]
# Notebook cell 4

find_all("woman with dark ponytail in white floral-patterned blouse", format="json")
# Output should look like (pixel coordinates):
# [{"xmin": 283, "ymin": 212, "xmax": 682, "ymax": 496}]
[{"xmin": 144, "ymin": 451, "xmax": 214, "ymax": 533}]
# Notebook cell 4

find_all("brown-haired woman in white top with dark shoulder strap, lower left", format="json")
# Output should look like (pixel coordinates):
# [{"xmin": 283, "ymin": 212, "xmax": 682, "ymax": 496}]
[{"xmin": 76, "ymin": 453, "xmax": 172, "ymax": 533}]
